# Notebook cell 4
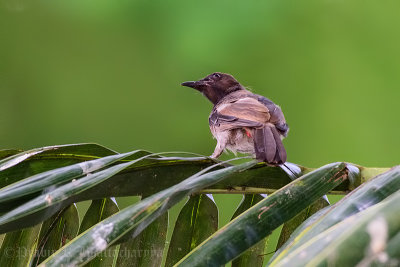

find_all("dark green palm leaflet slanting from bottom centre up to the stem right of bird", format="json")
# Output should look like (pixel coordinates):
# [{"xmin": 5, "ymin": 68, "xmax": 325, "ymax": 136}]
[{"xmin": 177, "ymin": 163, "xmax": 359, "ymax": 266}]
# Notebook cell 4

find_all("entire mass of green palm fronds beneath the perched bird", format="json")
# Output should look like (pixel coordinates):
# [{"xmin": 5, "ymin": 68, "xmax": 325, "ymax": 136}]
[{"xmin": 0, "ymin": 144, "xmax": 400, "ymax": 266}]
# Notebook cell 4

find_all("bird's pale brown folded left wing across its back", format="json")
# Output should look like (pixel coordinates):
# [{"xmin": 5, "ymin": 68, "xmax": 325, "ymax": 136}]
[{"xmin": 210, "ymin": 97, "xmax": 270, "ymax": 131}]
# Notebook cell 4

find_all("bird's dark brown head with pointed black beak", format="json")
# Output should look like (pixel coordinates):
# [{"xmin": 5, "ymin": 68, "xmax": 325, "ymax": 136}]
[{"xmin": 182, "ymin": 72, "xmax": 244, "ymax": 104}]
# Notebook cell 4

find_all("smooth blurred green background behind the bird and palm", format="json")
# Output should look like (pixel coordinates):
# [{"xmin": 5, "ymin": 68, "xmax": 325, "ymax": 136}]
[{"xmin": 0, "ymin": 0, "xmax": 400, "ymax": 264}]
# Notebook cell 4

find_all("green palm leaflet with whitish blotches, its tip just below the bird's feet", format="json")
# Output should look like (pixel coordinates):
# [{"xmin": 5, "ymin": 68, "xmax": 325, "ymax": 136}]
[{"xmin": 39, "ymin": 161, "xmax": 256, "ymax": 266}]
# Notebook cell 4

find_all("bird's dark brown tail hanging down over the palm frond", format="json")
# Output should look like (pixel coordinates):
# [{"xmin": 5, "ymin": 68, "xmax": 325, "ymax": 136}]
[{"xmin": 254, "ymin": 124, "xmax": 286, "ymax": 165}]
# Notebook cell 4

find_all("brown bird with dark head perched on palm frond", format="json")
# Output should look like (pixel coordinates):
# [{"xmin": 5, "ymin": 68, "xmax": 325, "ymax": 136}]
[{"xmin": 181, "ymin": 72, "xmax": 289, "ymax": 166}]
